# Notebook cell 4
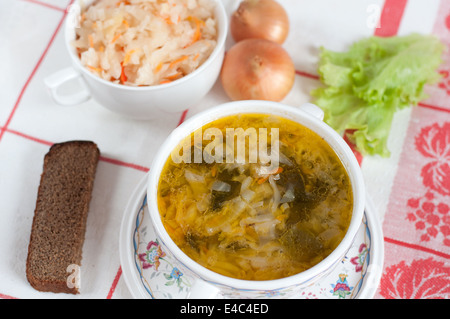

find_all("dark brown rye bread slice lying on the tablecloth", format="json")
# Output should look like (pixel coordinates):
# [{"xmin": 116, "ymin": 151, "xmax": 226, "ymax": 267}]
[{"xmin": 26, "ymin": 141, "xmax": 100, "ymax": 294}]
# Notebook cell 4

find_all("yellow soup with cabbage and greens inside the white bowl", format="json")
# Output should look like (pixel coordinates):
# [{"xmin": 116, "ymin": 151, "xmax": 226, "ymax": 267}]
[{"xmin": 158, "ymin": 114, "xmax": 353, "ymax": 280}]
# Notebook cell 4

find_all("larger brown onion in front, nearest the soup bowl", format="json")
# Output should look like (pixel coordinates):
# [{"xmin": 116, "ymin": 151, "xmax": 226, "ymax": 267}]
[{"xmin": 220, "ymin": 39, "xmax": 295, "ymax": 102}]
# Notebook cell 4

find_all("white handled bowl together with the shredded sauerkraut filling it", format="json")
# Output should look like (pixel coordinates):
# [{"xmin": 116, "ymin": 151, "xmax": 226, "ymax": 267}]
[{"xmin": 46, "ymin": 0, "xmax": 227, "ymax": 119}]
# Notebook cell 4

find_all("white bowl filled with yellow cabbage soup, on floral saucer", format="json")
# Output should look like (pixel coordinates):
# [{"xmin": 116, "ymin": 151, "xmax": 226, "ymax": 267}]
[{"xmin": 147, "ymin": 101, "xmax": 365, "ymax": 298}]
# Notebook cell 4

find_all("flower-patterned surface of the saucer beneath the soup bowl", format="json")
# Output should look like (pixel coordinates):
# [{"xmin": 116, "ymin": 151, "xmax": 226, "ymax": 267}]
[{"xmin": 132, "ymin": 195, "xmax": 381, "ymax": 299}]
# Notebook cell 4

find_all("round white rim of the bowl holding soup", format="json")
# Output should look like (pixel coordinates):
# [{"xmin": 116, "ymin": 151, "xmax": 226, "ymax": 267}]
[{"xmin": 147, "ymin": 100, "xmax": 365, "ymax": 291}]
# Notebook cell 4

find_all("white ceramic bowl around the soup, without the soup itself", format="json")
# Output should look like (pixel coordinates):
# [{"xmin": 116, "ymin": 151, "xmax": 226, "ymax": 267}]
[{"xmin": 147, "ymin": 101, "xmax": 365, "ymax": 298}]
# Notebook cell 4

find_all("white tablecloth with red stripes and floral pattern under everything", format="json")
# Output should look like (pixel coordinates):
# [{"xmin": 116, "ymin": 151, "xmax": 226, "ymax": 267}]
[{"xmin": 0, "ymin": 0, "xmax": 450, "ymax": 298}]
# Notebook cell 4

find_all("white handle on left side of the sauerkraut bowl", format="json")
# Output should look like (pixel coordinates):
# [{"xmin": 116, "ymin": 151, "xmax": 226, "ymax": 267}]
[{"xmin": 44, "ymin": 67, "xmax": 91, "ymax": 106}]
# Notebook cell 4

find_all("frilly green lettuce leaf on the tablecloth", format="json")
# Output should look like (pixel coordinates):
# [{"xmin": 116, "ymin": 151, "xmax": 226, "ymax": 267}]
[{"xmin": 311, "ymin": 34, "xmax": 444, "ymax": 157}]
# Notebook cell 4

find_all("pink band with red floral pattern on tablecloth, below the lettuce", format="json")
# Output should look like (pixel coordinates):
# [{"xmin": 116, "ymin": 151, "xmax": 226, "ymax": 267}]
[{"xmin": 377, "ymin": 107, "xmax": 450, "ymax": 298}]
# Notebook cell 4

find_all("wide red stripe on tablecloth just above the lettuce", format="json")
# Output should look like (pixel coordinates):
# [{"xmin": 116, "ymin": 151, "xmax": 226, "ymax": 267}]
[{"xmin": 375, "ymin": 0, "xmax": 408, "ymax": 37}]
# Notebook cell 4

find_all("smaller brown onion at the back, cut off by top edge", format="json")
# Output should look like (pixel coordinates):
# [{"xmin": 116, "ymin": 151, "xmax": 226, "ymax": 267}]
[{"xmin": 230, "ymin": 0, "xmax": 289, "ymax": 44}]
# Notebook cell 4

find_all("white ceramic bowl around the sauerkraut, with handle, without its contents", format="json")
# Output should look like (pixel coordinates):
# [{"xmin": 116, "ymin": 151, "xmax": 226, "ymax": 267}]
[{"xmin": 45, "ymin": 0, "xmax": 228, "ymax": 119}]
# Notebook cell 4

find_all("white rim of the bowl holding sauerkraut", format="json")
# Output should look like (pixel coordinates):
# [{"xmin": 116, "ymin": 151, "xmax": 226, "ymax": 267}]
[{"xmin": 64, "ymin": 0, "xmax": 228, "ymax": 92}]
